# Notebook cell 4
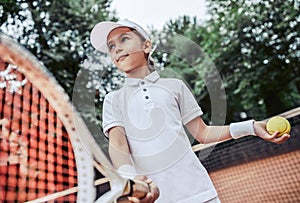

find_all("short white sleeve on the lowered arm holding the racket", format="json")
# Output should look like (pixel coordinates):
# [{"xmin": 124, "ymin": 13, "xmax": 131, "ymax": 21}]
[{"xmin": 102, "ymin": 92, "xmax": 124, "ymax": 137}]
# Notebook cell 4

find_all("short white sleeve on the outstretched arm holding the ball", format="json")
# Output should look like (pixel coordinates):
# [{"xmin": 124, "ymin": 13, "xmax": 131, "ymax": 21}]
[{"xmin": 179, "ymin": 81, "xmax": 203, "ymax": 125}]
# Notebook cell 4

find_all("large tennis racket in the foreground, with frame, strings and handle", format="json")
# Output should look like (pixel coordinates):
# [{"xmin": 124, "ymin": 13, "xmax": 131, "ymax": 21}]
[{"xmin": 0, "ymin": 33, "xmax": 149, "ymax": 203}]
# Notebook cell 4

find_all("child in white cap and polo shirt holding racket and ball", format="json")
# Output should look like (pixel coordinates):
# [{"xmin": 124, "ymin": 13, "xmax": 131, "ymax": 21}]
[{"xmin": 91, "ymin": 20, "xmax": 290, "ymax": 203}]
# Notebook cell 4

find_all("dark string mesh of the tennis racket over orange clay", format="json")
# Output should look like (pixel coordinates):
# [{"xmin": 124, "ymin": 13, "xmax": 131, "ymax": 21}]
[{"xmin": 0, "ymin": 61, "xmax": 77, "ymax": 202}]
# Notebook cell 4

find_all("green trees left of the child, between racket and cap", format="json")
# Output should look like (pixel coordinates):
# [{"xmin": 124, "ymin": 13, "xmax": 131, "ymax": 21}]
[{"xmin": 0, "ymin": 0, "xmax": 115, "ymax": 145}]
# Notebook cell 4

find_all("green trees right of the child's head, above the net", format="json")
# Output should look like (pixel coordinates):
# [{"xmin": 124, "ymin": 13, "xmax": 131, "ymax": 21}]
[{"xmin": 158, "ymin": 0, "xmax": 300, "ymax": 122}]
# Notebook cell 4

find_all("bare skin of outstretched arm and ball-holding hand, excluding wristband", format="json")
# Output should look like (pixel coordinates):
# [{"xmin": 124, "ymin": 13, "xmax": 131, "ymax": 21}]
[{"xmin": 186, "ymin": 117, "xmax": 290, "ymax": 144}]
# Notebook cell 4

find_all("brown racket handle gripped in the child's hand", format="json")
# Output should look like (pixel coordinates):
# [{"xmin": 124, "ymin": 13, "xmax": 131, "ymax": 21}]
[{"xmin": 117, "ymin": 180, "xmax": 151, "ymax": 203}]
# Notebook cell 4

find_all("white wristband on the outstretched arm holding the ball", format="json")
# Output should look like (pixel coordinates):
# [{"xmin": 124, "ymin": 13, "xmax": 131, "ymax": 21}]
[{"xmin": 229, "ymin": 120, "xmax": 256, "ymax": 139}]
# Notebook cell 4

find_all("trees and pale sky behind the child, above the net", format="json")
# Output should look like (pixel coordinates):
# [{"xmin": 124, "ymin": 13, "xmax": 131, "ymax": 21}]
[{"xmin": 0, "ymin": 0, "xmax": 300, "ymax": 143}]
